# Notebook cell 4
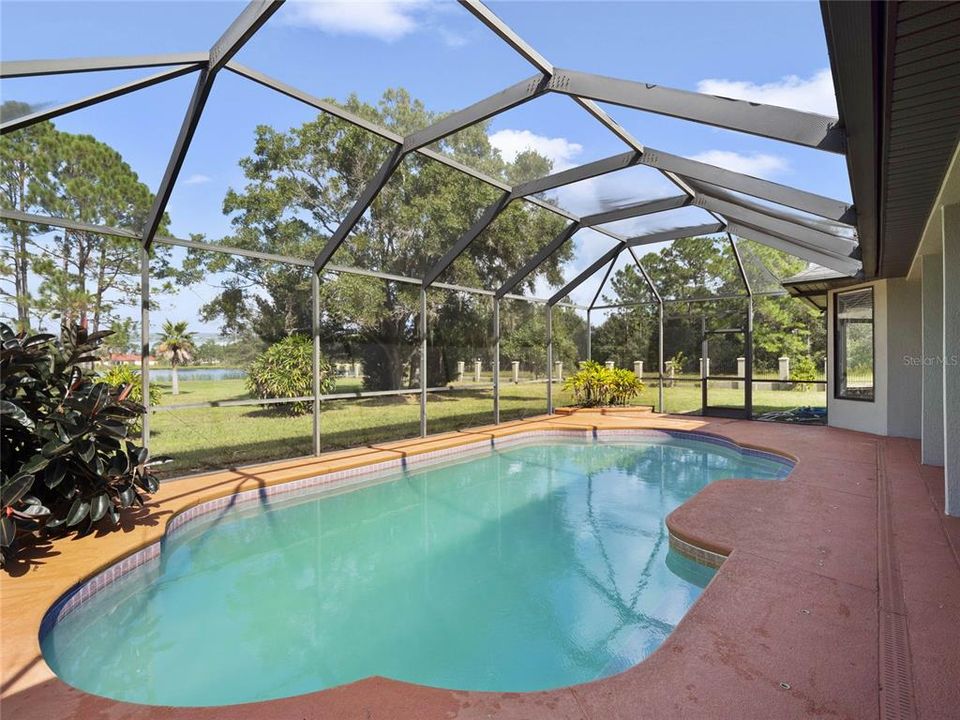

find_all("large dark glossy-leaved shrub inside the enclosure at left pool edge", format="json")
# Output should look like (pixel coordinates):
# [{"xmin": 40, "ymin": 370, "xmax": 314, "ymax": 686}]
[{"xmin": 0, "ymin": 323, "xmax": 164, "ymax": 564}]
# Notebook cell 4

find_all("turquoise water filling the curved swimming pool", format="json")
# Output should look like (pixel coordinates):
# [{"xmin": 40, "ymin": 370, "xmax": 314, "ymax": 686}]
[{"xmin": 42, "ymin": 437, "xmax": 790, "ymax": 706}]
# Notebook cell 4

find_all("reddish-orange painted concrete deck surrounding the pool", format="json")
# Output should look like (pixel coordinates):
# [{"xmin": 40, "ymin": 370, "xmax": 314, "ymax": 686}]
[{"xmin": 0, "ymin": 412, "xmax": 960, "ymax": 720}]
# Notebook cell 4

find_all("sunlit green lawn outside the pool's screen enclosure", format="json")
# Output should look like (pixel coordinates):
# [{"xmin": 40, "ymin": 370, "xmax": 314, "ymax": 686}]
[{"xmin": 150, "ymin": 375, "xmax": 826, "ymax": 476}]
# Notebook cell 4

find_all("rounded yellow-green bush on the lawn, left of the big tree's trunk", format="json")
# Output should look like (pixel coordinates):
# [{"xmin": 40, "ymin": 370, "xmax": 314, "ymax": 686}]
[{"xmin": 247, "ymin": 335, "xmax": 336, "ymax": 415}]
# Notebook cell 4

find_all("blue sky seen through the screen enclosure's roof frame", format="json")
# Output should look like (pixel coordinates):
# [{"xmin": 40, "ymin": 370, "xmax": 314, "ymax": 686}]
[{"xmin": 0, "ymin": 0, "xmax": 849, "ymax": 326}]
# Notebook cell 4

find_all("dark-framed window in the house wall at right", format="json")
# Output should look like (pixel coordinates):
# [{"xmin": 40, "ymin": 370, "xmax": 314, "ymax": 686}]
[{"xmin": 833, "ymin": 288, "xmax": 873, "ymax": 402}]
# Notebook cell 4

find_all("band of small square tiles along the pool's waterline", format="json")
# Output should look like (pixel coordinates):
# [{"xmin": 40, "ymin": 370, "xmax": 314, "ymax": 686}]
[{"xmin": 39, "ymin": 428, "xmax": 796, "ymax": 642}]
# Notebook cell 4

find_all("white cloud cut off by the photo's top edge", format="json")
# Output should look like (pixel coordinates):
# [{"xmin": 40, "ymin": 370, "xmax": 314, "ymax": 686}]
[{"xmin": 282, "ymin": 0, "xmax": 427, "ymax": 42}]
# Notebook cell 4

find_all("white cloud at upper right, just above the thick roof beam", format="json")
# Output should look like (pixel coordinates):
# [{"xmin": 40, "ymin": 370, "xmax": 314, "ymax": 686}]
[{"xmin": 697, "ymin": 69, "xmax": 837, "ymax": 116}]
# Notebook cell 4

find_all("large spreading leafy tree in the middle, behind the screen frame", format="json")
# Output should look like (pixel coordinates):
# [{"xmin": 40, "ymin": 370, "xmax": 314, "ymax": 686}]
[{"xmin": 192, "ymin": 90, "xmax": 572, "ymax": 389}]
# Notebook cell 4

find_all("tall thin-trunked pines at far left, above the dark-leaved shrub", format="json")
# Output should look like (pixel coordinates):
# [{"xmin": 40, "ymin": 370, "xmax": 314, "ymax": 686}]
[{"xmin": 0, "ymin": 102, "xmax": 170, "ymax": 332}]
